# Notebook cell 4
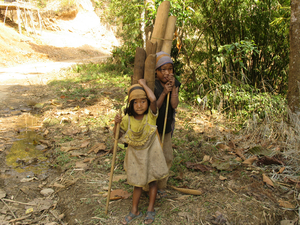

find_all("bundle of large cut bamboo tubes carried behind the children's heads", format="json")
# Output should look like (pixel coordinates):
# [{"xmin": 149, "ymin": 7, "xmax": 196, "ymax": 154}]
[{"xmin": 131, "ymin": 1, "xmax": 176, "ymax": 91}]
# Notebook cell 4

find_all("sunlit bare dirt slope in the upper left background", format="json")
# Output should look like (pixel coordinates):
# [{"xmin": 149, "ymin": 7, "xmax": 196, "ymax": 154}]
[{"xmin": 0, "ymin": 1, "xmax": 119, "ymax": 67}]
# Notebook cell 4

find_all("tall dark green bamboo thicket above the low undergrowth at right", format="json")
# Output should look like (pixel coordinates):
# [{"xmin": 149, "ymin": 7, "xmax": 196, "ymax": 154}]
[{"xmin": 183, "ymin": 0, "xmax": 289, "ymax": 93}]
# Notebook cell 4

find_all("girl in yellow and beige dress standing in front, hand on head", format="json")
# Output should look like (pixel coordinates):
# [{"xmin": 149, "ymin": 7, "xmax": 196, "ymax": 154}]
[{"xmin": 114, "ymin": 79, "xmax": 168, "ymax": 224}]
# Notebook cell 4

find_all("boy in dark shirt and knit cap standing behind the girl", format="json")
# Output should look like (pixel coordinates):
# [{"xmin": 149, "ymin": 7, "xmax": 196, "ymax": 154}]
[{"xmin": 154, "ymin": 52, "xmax": 181, "ymax": 192}]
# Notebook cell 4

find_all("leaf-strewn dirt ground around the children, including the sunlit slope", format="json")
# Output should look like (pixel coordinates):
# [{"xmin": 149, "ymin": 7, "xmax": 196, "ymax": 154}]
[{"xmin": 0, "ymin": 2, "xmax": 300, "ymax": 225}]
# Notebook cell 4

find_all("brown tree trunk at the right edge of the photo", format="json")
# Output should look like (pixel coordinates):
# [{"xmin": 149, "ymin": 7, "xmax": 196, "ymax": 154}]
[{"xmin": 287, "ymin": 0, "xmax": 300, "ymax": 114}]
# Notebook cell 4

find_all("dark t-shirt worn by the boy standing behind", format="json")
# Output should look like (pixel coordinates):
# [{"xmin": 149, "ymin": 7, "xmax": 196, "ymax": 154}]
[{"xmin": 154, "ymin": 78, "xmax": 181, "ymax": 134}]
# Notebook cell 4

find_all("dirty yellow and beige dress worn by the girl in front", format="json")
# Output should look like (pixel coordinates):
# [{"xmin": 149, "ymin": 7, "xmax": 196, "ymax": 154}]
[{"xmin": 124, "ymin": 110, "xmax": 169, "ymax": 187}]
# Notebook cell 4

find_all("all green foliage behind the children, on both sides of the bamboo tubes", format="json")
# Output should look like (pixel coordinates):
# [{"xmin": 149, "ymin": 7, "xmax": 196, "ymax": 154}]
[{"xmin": 99, "ymin": 0, "xmax": 290, "ymax": 123}]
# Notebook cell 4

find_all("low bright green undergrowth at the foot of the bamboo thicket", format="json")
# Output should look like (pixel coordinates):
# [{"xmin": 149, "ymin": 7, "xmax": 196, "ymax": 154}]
[{"xmin": 182, "ymin": 83, "xmax": 287, "ymax": 123}]
